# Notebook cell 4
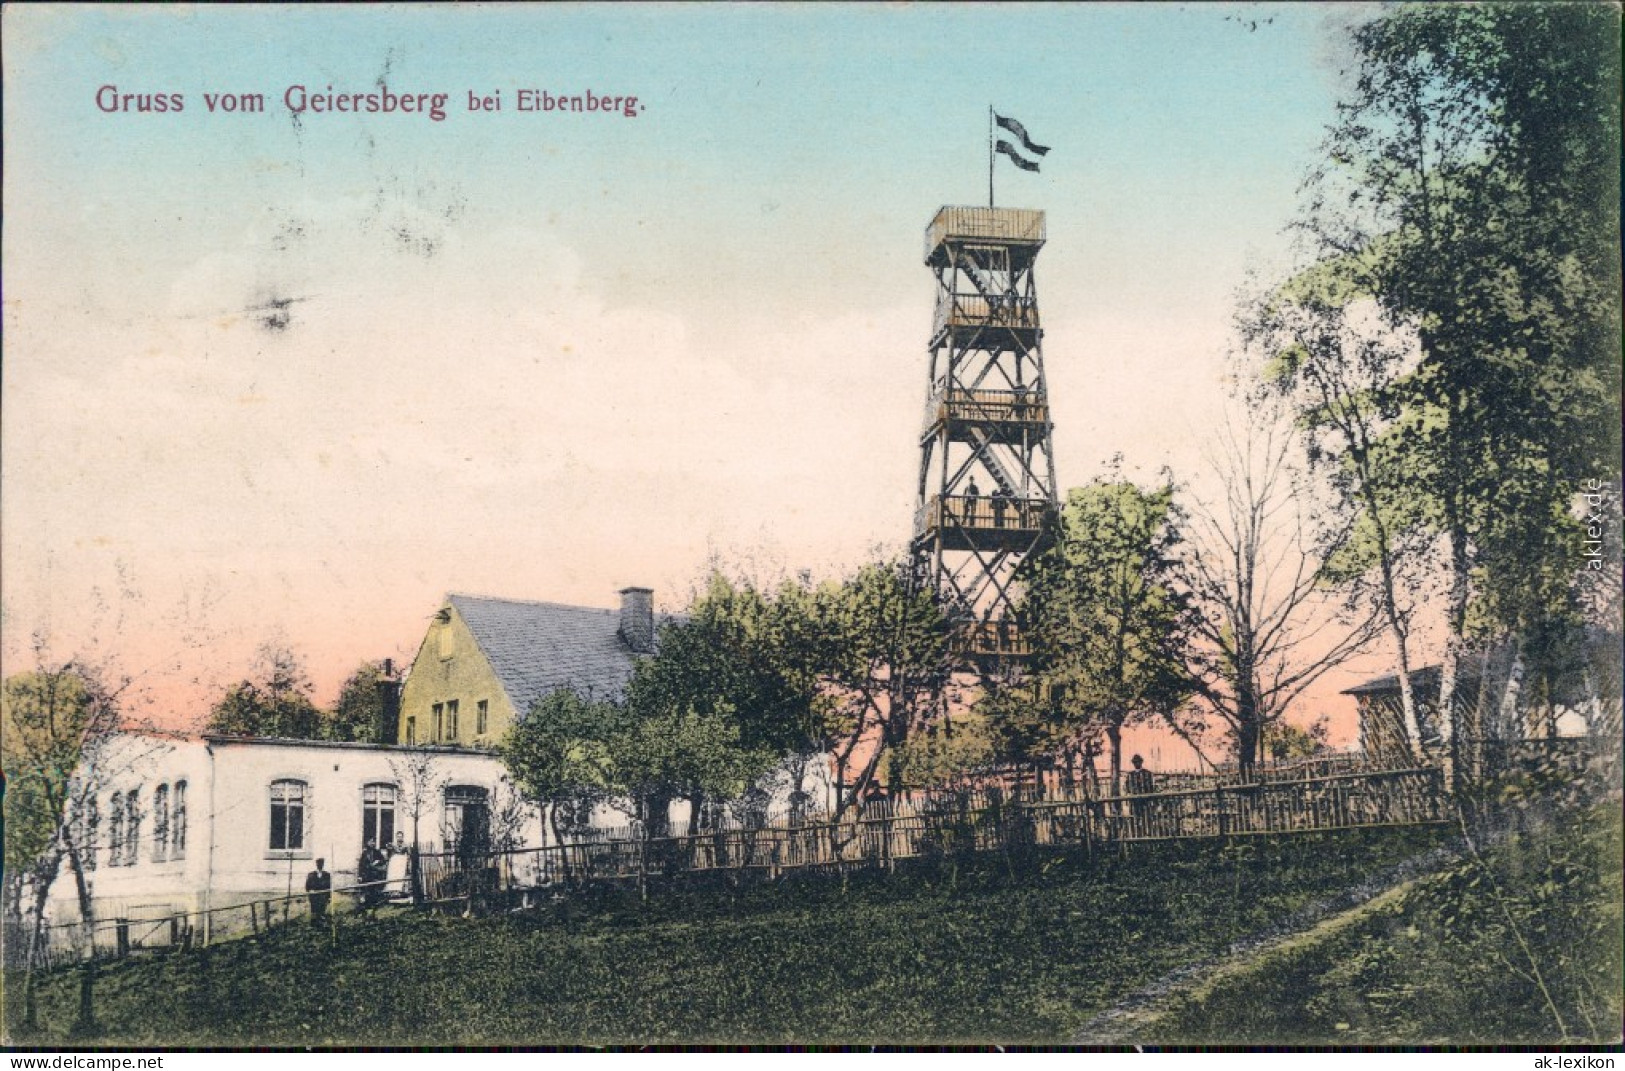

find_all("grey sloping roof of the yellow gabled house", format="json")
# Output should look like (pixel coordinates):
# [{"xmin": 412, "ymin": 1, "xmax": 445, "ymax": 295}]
[{"xmin": 447, "ymin": 595, "xmax": 671, "ymax": 717}]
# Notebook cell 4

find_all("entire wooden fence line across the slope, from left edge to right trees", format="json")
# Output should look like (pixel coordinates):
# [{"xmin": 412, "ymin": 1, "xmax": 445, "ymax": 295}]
[{"xmin": 0, "ymin": 767, "xmax": 1448, "ymax": 967}]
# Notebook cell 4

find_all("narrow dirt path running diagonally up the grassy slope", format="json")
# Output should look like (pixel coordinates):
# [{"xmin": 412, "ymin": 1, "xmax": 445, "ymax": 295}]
[{"xmin": 1073, "ymin": 845, "xmax": 1461, "ymax": 1045}]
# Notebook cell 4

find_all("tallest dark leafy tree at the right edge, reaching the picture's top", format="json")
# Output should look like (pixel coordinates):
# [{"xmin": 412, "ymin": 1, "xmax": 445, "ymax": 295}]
[{"xmin": 1303, "ymin": 3, "xmax": 1620, "ymax": 744}]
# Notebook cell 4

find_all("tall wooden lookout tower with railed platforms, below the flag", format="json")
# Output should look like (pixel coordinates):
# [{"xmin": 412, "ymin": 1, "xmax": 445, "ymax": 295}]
[{"xmin": 912, "ymin": 206, "xmax": 1058, "ymax": 671}]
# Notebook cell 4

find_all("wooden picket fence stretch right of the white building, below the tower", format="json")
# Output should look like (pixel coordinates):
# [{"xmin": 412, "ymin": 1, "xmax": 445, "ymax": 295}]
[{"xmin": 418, "ymin": 767, "xmax": 1446, "ymax": 902}]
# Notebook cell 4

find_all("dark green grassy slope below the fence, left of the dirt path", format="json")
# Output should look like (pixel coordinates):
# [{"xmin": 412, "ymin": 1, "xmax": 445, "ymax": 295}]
[{"xmin": 7, "ymin": 829, "xmax": 1462, "ymax": 1045}]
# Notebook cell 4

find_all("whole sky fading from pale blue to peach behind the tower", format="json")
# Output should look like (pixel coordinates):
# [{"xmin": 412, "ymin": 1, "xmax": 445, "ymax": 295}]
[{"xmin": 0, "ymin": 3, "xmax": 1360, "ymax": 717}]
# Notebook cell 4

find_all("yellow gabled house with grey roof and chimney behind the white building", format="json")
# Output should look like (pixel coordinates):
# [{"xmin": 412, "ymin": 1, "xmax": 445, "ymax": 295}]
[{"xmin": 390, "ymin": 587, "xmax": 670, "ymax": 748}]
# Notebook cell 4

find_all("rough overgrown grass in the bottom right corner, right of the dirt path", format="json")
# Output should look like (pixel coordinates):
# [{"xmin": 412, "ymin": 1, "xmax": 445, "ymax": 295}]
[{"xmin": 1141, "ymin": 808, "xmax": 1625, "ymax": 1045}]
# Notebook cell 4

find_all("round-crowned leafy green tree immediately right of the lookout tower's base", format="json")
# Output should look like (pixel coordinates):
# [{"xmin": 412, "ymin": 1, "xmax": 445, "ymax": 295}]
[{"xmin": 1021, "ymin": 460, "xmax": 1191, "ymax": 795}]
